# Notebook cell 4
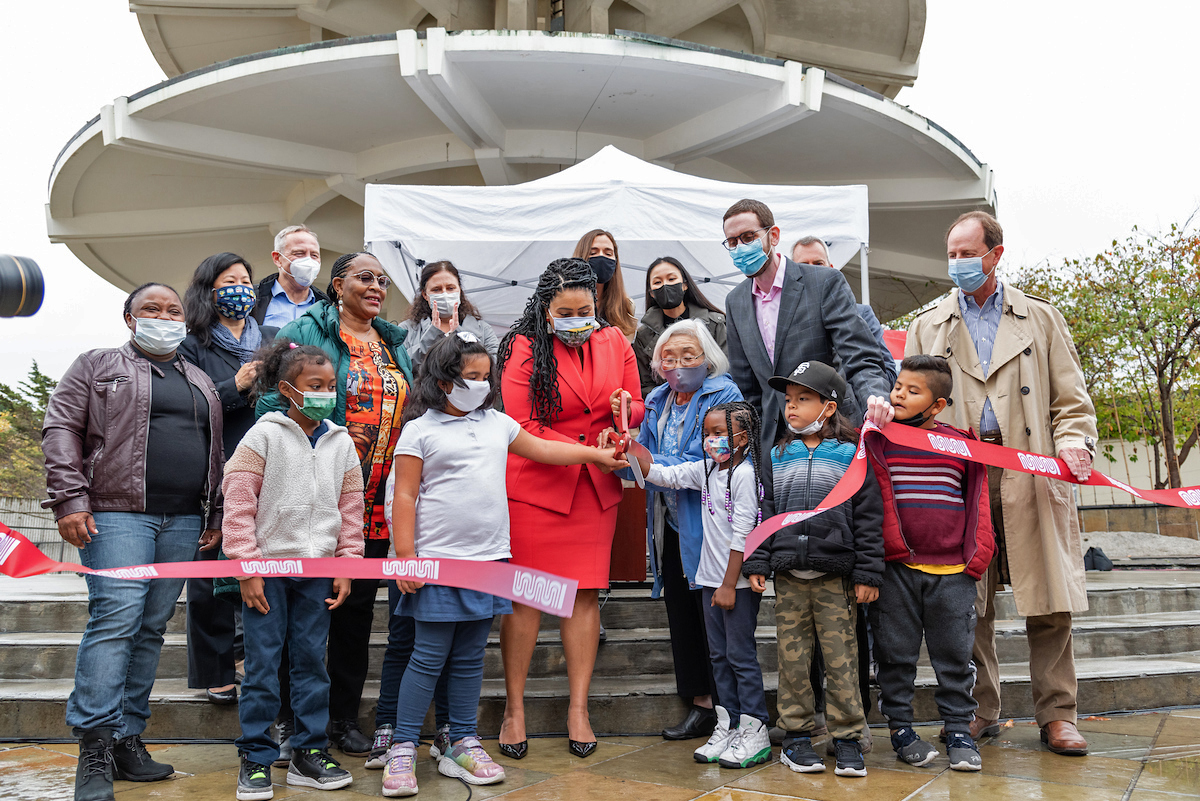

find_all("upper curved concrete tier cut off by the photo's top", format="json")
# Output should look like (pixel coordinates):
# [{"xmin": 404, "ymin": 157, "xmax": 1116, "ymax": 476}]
[{"xmin": 130, "ymin": 0, "xmax": 925, "ymax": 97}]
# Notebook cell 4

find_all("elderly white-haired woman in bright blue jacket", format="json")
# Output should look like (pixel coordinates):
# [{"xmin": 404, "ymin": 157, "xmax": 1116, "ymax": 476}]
[{"xmin": 623, "ymin": 318, "xmax": 742, "ymax": 740}]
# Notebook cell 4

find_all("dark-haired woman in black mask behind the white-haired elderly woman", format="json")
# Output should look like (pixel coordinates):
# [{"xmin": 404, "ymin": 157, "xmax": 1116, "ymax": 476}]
[{"xmin": 634, "ymin": 255, "xmax": 726, "ymax": 397}]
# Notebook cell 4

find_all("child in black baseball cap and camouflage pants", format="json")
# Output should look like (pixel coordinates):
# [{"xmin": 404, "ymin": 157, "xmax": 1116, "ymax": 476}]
[{"xmin": 742, "ymin": 361, "xmax": 883, "ymax": 776}]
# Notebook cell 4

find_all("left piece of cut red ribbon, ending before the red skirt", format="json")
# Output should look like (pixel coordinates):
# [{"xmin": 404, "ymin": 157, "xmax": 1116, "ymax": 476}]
[{"xmin": 0, "ymin": 523, "xmax": 580, "ymax": 618}]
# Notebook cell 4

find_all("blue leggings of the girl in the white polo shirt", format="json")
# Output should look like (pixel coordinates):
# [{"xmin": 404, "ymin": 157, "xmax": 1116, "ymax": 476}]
[{"xmin": 392, "ymin": 618, "xmax": 492, "ymax": 743}]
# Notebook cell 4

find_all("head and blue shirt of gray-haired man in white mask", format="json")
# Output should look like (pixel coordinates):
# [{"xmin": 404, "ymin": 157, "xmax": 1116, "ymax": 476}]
[{"xmin": 251, "ymin": 225, "xmax": 326, "ymax": 329}]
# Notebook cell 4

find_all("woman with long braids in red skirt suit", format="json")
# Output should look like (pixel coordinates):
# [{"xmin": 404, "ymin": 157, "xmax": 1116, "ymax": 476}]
[{"xmin": 498, "ymin": 259, "xmax": 644, "ymax": 759}]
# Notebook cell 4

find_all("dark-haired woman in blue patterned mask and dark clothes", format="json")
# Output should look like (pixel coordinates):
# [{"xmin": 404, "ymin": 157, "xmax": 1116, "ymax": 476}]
[{"xmin": 179, "ymin": 253, "xmax": 275, "ymax": 704}]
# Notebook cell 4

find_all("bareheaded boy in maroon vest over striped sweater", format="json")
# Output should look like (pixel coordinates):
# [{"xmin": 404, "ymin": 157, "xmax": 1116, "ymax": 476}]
[{"xmin": 866, "ymin": 355, "xmax": 995, "ymax": 771}]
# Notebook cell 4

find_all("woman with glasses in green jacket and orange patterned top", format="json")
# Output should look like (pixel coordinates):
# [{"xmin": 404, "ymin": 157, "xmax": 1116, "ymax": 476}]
[{"xmin": 257, "ymin": 253, "xmax": 413, "ymax": 757}]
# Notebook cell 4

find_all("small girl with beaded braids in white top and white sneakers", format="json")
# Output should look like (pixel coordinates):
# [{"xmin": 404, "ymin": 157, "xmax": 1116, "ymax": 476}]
[{"xmin": 624, "ymin": 401, "xmax": 770, "ymax": 767}]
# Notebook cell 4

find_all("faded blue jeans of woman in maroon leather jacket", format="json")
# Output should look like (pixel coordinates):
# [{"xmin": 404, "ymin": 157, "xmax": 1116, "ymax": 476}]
[{"xmin": 66, "ymin": 512, "xmax": 202, "ymax": 737}]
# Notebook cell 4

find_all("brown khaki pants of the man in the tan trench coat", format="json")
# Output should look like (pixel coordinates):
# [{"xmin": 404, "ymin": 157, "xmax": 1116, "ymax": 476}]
[{"xmin": 974, "ymin": 468, "xmax": 1078, "ymax": 725}]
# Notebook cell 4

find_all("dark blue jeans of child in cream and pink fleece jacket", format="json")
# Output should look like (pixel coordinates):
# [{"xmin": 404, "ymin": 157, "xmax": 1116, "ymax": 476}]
[{"xmin": 234, "ymin": 577, "xmax": 334, "ymax": 765}]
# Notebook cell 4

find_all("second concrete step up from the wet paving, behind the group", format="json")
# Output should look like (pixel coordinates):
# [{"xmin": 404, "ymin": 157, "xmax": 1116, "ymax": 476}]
[{"xmin": 9, "ymin": 612, "xmax": 1200, "ymax": 679}]
